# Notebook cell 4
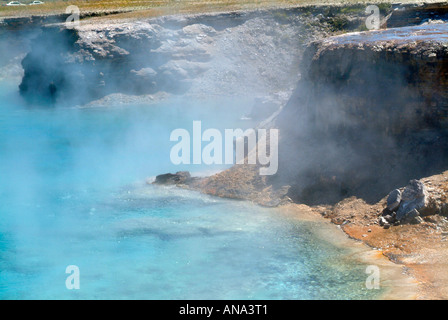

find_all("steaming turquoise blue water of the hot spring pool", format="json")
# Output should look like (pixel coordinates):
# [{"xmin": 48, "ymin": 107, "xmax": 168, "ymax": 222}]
[{"xmin": 0, "ymin": 83, "xmax": 378, "ymax": 299}]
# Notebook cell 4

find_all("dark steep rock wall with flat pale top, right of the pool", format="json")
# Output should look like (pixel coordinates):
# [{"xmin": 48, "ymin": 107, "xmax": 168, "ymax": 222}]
[{"xmin": 272, "ymin": 24, "xmax": 448, "ymax": 203}]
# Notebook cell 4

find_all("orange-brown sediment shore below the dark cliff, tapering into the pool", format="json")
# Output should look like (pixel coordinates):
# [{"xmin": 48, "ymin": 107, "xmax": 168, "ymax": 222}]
[{"xmin": 178, "ymin": 166, "xmax": 448, "ymax": 300}]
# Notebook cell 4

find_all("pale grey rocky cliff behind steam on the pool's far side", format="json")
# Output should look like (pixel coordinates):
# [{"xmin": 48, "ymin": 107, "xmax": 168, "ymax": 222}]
[{"xmin": 15, "ymin": 8, "xmax": 344, "ymax": 104}]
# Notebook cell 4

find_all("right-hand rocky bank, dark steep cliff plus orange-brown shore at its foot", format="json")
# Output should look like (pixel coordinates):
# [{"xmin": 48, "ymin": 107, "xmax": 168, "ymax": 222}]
[{"xmin": 150, "ymin": 3, "xmax": 448, "ymax": 299}]
